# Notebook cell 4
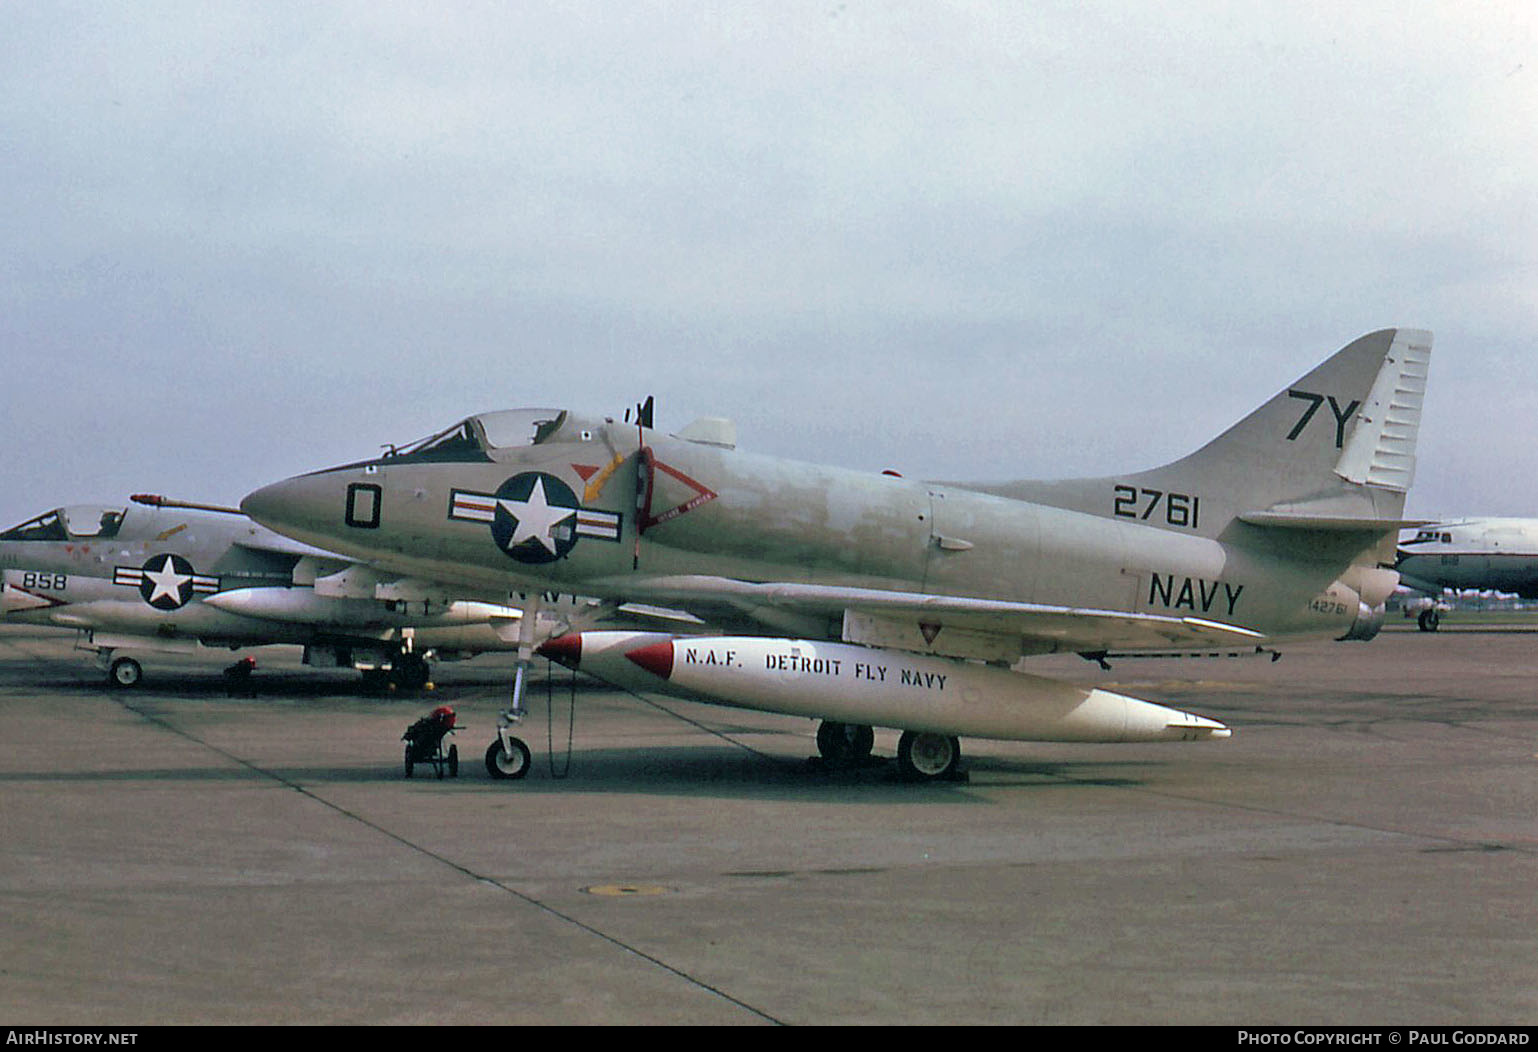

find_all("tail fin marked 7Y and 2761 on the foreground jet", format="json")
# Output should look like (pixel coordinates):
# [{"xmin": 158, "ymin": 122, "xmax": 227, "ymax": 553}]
[{"xmin": 984, "ymin": 329, "xmax": 1432, "ymax": 537}]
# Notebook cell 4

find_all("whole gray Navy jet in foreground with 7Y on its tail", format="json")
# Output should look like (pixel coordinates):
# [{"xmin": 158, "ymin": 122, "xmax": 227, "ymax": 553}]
[{"xmin": 243, "ymin": 329, "xmax": 1430, "ymax": 778}]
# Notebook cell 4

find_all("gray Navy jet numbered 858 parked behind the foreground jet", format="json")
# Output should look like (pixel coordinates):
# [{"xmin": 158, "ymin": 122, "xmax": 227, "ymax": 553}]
[{"xmin": 0, "ymin": 497, "xmax": 578, "ymax": 687}]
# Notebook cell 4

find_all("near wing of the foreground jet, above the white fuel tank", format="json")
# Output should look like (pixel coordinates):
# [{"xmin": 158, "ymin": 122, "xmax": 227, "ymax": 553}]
[{"xmin": 599, "ymin": 575, "xmax": 1266, "ymax": 660}]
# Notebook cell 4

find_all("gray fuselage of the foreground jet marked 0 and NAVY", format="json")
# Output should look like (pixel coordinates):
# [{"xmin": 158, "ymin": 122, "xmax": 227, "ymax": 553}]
[{"xmin": 243, "ymin": 414, "xmax": 1393, "ymax": 649}]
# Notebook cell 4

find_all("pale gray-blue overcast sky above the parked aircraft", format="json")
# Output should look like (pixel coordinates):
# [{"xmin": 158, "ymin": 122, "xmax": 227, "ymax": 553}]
[{"xmin": 0, "ymin": 0, "xmax": 1538, "ymax": 526}]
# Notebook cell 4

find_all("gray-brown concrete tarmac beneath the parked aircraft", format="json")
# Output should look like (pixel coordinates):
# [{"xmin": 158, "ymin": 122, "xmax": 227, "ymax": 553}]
[{"xmin": 0, "ymin": 626, "xmax": 1538, "ymax": 1027}]
